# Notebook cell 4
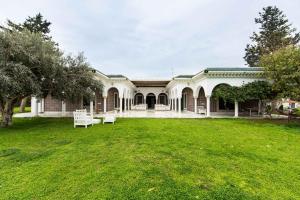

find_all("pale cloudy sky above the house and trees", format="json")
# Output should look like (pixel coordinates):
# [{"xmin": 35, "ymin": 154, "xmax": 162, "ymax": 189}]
[{"xmin": 0, "ymin": 0, "xmax": 300, "ymax": 79}]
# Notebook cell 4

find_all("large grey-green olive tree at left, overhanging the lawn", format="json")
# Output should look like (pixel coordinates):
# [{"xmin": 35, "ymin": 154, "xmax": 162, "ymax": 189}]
[{"xmin": 0, "ymin": 29, "xmax": 102, "ymax": 127}]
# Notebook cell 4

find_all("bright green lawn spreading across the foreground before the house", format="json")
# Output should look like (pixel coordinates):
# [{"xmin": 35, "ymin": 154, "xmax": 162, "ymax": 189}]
[{"xmin": 0, "ymin": 118, "xmax": 300, "ymax": 200}]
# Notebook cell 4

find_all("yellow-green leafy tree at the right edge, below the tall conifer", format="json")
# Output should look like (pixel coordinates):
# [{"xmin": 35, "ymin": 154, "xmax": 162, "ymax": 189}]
[{"xmin": 260, "ymin": 46, "xmax": 300, "ymax": 101}]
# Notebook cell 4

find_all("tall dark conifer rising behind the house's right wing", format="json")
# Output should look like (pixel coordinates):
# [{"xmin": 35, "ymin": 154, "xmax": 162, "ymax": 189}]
[{"xmin": 244, "ymin": 6, "xmax": 300, "ymax": 67}]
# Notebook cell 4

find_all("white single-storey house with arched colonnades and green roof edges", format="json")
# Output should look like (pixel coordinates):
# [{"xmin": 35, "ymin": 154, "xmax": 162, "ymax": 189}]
[{"xmin": 31, "ymin": 67, "xmax": 264, "ymax": 117}]
